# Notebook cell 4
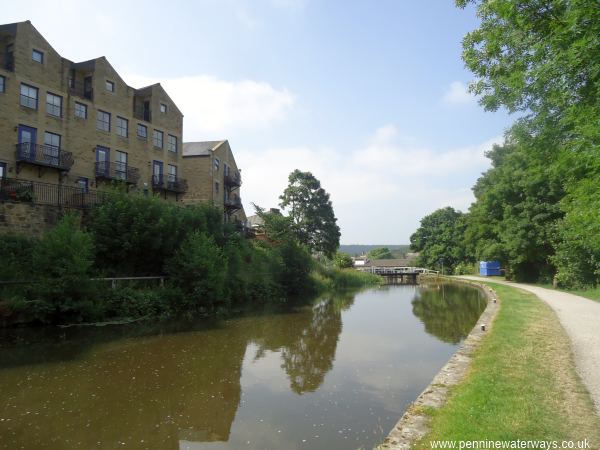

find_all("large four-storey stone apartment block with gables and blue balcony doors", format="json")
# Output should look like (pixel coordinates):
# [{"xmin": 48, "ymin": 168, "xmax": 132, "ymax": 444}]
[{"xmin": 0, "ymin": 21, "xmax": 185, "ymax": 200}]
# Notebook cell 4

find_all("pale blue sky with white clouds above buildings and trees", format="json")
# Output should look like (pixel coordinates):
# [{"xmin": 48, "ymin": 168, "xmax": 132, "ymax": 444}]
[{"xmin": 0, "ymin": 0, "xmax": 513, "ymax": 244}]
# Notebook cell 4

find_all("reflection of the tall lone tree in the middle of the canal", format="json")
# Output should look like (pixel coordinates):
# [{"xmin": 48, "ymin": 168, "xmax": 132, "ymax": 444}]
[{"xmin": 252, "ymin": 296, "xmax": 354, "ymax": 394}]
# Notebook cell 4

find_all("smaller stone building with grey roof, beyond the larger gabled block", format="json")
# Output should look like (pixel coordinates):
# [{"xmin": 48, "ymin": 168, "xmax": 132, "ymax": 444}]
[{"xmin": 183, "ymin": 140, "xmax": 246, "ymax": 224}]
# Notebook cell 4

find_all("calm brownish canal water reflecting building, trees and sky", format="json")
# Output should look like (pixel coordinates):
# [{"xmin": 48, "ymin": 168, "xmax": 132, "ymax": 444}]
[{"xmin": 0, "ymin": 284, "xmax": 485, "ymax": 450}]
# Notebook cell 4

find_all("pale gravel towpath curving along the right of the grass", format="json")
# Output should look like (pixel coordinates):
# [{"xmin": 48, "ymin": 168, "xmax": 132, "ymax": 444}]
[{"xmin": 460, "ymin": 276, "xmax": 600, "ymax": 415}]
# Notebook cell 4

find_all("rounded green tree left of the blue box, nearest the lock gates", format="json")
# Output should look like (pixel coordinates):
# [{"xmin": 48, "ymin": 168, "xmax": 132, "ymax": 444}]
[{"xmin": 410, "ymin": 207, "xmax": 466, "ymax": 272}]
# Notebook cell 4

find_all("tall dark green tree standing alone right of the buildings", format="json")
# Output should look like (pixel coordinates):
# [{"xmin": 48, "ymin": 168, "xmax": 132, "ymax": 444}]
[{"xmin": 279, "ymin": 169, "xmax": 340, "ymax": 256}]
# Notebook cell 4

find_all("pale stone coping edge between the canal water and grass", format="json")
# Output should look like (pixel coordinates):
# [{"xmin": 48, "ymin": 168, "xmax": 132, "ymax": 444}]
[{"xmin": 377, "ymin": 276, "xmax": 500, "ymax": 450}]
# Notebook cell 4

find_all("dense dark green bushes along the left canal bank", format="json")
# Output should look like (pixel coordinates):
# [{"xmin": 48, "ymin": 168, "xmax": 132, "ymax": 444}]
[{"xmin": 0, "ymin": 171, "xmax": 379, "ymax": 323}]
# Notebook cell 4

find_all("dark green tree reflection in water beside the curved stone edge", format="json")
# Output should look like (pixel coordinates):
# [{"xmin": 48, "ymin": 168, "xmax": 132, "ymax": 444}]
[{"xmin": 412, "ymin": 284, "xmax": 486, "ymax": 344}]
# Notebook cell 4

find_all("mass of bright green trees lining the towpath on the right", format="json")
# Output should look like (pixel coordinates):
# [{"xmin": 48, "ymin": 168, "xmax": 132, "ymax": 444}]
[{"xmin": 411, "ymin": 0, "xmax": 600, "ymax": 288}]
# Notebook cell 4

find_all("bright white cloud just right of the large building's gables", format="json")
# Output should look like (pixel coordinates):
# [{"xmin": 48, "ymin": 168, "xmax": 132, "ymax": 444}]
[{"xmin": 124, "ymin": 75, "xmax": 295, "ymax": 141}]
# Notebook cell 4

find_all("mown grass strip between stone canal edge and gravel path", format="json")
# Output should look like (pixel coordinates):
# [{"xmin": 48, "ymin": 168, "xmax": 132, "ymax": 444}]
[{"xmin": 416, "ymin": 284, "xmax": 600, "ymax": 448}]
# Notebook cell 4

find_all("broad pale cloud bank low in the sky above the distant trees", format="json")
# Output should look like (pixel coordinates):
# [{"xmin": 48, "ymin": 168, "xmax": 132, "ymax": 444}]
[{"xmin": 234, "ymin": 125, "xmax": 502, "ymax": 244}]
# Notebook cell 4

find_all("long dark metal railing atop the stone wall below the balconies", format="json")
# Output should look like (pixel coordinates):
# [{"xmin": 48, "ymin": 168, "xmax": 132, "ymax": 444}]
[{"xmin": 0, "ymin": 178, "xmax": 105, "ymax": 208}]
